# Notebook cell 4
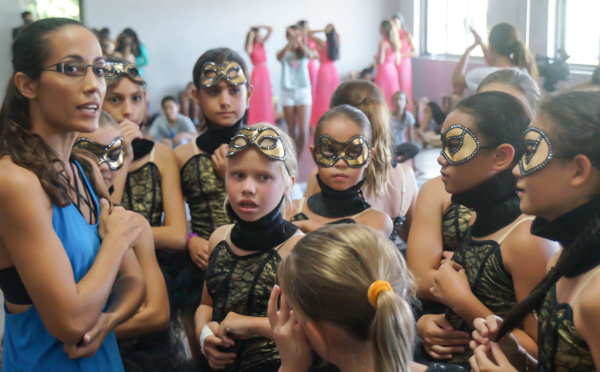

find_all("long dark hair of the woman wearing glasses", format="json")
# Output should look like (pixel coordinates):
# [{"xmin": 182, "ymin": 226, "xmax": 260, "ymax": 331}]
[{"xmin": 0, "ymin": 18, "xmax": 106, "ymax": 207}]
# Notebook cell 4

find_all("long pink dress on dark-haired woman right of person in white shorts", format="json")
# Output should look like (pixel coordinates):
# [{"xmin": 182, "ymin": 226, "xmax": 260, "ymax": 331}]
[{"xmin": 310, "ymin": 43, "xmax": 340, "ymax": 128}]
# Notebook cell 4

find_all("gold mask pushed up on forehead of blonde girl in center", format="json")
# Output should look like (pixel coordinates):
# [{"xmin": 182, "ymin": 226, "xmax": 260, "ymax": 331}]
[{"xmin": 227, "ymin": 127, "xmax": 287, "ymax": 160}]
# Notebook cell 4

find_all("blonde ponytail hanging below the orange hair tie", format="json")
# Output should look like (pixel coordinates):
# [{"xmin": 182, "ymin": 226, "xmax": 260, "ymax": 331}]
[{"xmin": 371, "ymin": 291, "xmax": 415, "ymax": 372}]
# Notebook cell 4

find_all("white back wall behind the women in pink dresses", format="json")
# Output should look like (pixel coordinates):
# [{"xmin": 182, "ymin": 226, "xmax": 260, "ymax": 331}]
[{"xmin": 84, "ymin": 0, "xmax": 396, "ymax": 111}]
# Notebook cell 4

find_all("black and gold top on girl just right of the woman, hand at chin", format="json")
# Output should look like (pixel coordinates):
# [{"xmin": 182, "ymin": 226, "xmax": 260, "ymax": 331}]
[{"xmin": 121, "ymin": 148, "xmax": 164, "ymax": 226}]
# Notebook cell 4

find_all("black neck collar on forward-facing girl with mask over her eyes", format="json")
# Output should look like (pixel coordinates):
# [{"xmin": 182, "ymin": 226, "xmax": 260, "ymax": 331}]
[{"xmin": 306, "ymin": 174, "xmax": 371, "ymax": 218}]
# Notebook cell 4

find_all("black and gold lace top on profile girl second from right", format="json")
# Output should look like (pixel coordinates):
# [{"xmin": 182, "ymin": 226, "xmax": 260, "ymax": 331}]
[{"xmin": 446, "ymin": 217, "xmax": 533, "ymax": 363}]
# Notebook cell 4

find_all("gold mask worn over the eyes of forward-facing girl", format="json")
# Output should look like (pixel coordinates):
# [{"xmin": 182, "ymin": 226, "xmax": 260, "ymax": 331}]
[{"xmin": 313, "ymin": 134, "xmax": 371, "ymax": 168}]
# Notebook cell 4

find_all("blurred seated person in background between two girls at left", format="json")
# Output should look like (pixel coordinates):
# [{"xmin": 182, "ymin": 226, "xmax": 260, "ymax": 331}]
[{"xmin": 148, "ymin": 96, "xmax": 198, "ymax": 147}]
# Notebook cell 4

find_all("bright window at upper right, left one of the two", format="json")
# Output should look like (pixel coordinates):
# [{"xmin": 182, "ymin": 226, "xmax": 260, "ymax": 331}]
[{"xmin": 424, "ymin": 0, "xmax": 487, "ymax": 56}]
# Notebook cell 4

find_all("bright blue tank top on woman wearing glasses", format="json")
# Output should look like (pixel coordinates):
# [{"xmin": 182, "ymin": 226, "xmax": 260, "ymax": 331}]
[{"xmin": 2, "ymin": 163, "xmax": 123, "ymax": 372}]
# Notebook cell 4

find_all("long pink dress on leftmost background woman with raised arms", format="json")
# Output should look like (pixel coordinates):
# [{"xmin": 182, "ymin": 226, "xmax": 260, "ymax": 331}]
[{"xmin": 248, "ymin": 42, "xmax": 275, "ymax": 125}]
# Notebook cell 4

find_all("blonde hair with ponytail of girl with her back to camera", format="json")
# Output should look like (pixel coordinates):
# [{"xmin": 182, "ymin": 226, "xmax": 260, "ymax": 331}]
[{"xmin": 277, "ymin": 224, "xmax": 415, "ymax": 372}]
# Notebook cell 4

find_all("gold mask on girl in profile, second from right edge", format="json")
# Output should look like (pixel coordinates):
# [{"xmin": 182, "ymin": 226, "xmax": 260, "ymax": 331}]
[{"xmin": 441, "ymin": 124, "xmax": 494, "ymax": 165}]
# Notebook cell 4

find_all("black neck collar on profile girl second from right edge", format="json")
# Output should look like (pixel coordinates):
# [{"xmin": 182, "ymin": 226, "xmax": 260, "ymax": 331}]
[{"xmin": 452, "ymin": 169, "xmax": 521, "ymax": 237}]
